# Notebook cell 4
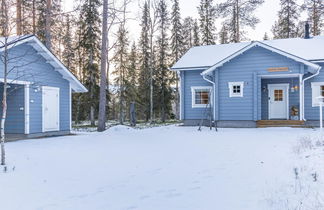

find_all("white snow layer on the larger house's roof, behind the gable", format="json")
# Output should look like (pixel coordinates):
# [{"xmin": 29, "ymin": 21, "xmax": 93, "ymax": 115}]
[{"xmin": 172, "ymin": 36, "xmax": 324, "ymax": 70}]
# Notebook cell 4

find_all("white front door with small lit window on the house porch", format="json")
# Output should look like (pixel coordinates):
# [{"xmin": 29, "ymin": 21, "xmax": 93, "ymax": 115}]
[{"xmin": 268, "ymin": 84, "xmax": 289, "ymax": 120}]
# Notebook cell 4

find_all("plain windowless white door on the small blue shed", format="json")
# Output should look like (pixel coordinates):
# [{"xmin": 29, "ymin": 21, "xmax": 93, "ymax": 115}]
[{"xmin": 42, "ymin": 86, "xmax": 60, "ymax": 132}]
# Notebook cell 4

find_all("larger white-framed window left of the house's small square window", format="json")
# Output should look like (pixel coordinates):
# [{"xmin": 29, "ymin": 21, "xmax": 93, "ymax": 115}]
[{"xmin": 191, "ymin": 86, "xmax": 212, "ymax": 108}]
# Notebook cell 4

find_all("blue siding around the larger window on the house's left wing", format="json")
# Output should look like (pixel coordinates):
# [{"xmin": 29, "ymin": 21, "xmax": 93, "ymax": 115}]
[{"xmin": 183, "ymin": 70, "xmax": 212, "ymax": 120}]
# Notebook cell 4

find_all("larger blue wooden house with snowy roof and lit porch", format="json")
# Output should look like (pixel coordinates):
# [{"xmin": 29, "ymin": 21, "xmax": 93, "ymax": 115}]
[{"xmin": 171, "ymin": 31, "xmax": 324, "ymax": 127}]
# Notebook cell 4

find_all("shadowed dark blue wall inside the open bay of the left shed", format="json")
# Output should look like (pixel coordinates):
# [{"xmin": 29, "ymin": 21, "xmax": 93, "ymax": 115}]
[{"xmin": 0, "ymin": 84, "xmax": 25, "ymax": 134}]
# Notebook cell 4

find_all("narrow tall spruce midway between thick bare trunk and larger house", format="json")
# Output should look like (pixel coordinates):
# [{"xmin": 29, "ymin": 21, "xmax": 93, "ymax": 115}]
[{"xmin": 138, "ymin": 1, "xmax": 150, "ymax": 121}]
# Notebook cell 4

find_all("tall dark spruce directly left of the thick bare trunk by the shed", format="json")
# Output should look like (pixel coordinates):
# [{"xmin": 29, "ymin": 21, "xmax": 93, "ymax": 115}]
[{"xmin": 79, "ymin": 0, "xmax": 101, "ymax": 126}]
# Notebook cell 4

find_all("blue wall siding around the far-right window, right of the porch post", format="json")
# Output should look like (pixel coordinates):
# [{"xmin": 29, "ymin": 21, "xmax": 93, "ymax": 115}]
[{"xmin": 304, "ymin": 63, "xmax": 324, "ymax": 120}]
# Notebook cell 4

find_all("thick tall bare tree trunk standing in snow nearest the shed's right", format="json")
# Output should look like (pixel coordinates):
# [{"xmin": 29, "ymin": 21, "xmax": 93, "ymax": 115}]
[{"xmin": 98, "ymin": 0, "xmax": 108, "ymax": 131}]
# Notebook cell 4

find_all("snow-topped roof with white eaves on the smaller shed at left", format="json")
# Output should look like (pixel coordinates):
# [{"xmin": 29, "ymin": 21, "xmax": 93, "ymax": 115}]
[{"xmin": 0, "ymin": 35, "xmax": 88, "ymax": 92}]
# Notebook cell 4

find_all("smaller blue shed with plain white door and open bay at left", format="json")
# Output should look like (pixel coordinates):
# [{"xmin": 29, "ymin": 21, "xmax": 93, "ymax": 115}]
[{"xmin": 0, "ymin": 35, "xmax": 87, "ymax": 138}]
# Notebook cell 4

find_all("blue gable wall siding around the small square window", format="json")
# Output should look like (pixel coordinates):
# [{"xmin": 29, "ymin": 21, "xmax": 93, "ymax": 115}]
[{"xmin": 218, "ymin": 47, "xmax": 300, "ymax": 120}]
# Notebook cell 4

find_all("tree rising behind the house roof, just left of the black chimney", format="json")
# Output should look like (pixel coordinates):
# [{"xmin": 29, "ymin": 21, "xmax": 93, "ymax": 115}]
[{"xmin": 272, "ymin": 0, "xmax": 300, "ymax": 39}]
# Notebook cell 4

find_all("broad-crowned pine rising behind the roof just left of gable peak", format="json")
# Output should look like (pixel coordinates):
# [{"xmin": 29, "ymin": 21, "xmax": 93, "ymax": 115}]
[{"xmin": 217, "ymin": 0, "xmax": 264, "ymax": 42}]
